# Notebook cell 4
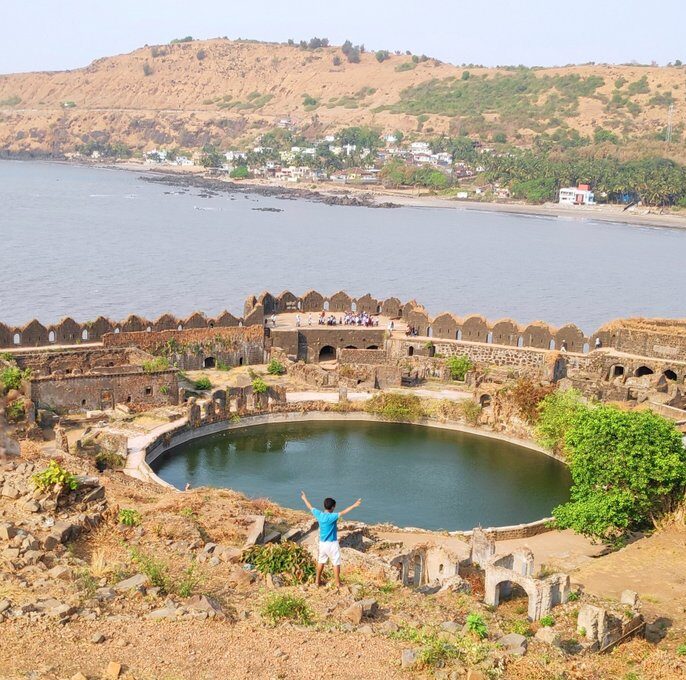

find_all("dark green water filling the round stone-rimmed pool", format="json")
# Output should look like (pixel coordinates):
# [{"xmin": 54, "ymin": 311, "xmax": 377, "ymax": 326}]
[{"xmin": 153, "ymin": 421, "xmax": 570, "ymax": 530}]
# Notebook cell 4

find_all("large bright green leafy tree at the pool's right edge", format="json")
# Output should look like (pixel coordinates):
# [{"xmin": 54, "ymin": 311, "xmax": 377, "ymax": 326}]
[{"xmin": 553, "ymin": 405, "xmax": 686, "ymax": 540}]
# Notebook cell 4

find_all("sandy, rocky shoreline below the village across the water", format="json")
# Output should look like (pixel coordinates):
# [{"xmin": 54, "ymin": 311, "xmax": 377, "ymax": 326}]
[{"xmin": 1, "ymin": 158, "xmax": 686, "ymax": 229}]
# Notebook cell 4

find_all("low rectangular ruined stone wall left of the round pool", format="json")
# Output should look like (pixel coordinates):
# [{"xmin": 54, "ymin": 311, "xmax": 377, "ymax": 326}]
[{"xmin": 31, "ymin": 367, "xmax": 179, "ymax": 411}]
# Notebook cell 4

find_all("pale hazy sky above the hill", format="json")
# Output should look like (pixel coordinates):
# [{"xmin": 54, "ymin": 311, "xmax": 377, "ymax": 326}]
[{"xmin": 0, "ymin": 0, "xmax": 686, "ymax": 73}]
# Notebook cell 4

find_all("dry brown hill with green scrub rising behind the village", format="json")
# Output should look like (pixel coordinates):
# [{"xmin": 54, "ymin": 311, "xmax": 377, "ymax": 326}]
[{"xmin": 0, "ymin": 39, "xmax": 686, "ymax": 154}]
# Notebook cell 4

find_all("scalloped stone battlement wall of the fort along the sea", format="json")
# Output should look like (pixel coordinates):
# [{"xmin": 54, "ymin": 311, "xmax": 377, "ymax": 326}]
[{"xmin": 0, "ymin": 290, "xmax": 686, "ymax": 360}]
